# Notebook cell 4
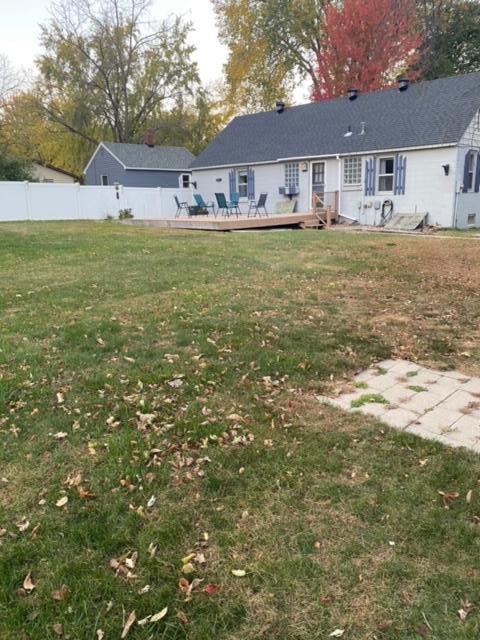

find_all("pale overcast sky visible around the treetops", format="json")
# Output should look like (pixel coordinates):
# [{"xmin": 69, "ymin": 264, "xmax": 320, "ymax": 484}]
[{"xmin": 0, "ymin": 0, "xmax": 227, "ymax": 82}]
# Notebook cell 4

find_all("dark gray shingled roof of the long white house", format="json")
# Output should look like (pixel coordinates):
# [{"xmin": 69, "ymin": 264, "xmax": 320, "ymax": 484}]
[{"xmin": 190, "ymin": 73, "xmax": 480, "ymax": 168}]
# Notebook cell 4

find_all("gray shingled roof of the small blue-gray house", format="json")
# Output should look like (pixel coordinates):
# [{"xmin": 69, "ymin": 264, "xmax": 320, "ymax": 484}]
[{"xmin": 102, "ymin": 142, "xmax": 195, "ymax": 171}]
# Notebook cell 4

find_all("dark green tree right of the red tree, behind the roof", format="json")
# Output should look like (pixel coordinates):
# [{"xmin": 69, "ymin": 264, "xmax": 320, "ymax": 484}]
[{"xmin": 417, "ymin": 0, "xmax": 480, "ymax": 79}]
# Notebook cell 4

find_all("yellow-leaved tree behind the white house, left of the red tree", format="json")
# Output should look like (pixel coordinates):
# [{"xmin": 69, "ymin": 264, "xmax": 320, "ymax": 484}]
[{"xmin": 212, "ymin": 0, "xmax": 328, "ymax": 112}]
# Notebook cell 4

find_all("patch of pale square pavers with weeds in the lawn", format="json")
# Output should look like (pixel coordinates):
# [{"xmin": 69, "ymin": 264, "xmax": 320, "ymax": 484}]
[{"xmin": 319, "ymin": 360, "xmax": 480, "ymax": 453}]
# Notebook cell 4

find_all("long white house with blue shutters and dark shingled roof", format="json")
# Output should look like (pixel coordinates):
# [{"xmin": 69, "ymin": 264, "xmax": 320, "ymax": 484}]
[{"xmin": 190, "ymin": 73, "xmax": 480, "ymax": 228}]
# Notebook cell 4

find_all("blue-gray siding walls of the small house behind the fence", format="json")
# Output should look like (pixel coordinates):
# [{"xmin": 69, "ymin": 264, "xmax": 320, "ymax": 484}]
[{"xmin": 85, "ymin": 147, "xmax": 189, "ymax": 188}]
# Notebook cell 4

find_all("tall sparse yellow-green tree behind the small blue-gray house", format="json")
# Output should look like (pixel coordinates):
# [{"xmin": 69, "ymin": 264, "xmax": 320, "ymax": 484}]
[{"xmin": 37, "ymin": 0, "xmax": 198, "ymax": 144}]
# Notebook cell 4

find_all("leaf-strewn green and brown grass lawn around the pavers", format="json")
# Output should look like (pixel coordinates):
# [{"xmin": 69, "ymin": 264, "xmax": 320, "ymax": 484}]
[{"xmin": 0, "ymin": 223, "xmax": 480, "ymax": 640}]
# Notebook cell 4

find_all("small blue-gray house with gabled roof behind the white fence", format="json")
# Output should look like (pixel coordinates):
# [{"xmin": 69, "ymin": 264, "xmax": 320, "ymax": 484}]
[{"xmin": 84, "ymin": 134, "xmax": 195, "ymax": 188}]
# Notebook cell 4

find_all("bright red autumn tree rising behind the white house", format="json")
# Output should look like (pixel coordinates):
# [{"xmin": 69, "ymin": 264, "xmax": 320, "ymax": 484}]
[{"xmin": 312, "ymin": 0, "xmax": 422, "ymax": 101}]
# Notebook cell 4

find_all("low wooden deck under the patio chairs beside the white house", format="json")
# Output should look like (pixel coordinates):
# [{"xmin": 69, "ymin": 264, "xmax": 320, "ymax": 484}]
[{"xmin": 124, "ymin": 213, "xmax": 318, "ymax": 231}]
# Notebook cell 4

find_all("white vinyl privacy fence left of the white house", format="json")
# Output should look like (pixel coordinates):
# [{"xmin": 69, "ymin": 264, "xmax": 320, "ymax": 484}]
[{"xmin": 0, "ymin": 182, "xmax": 192, "ymax": 222}]
